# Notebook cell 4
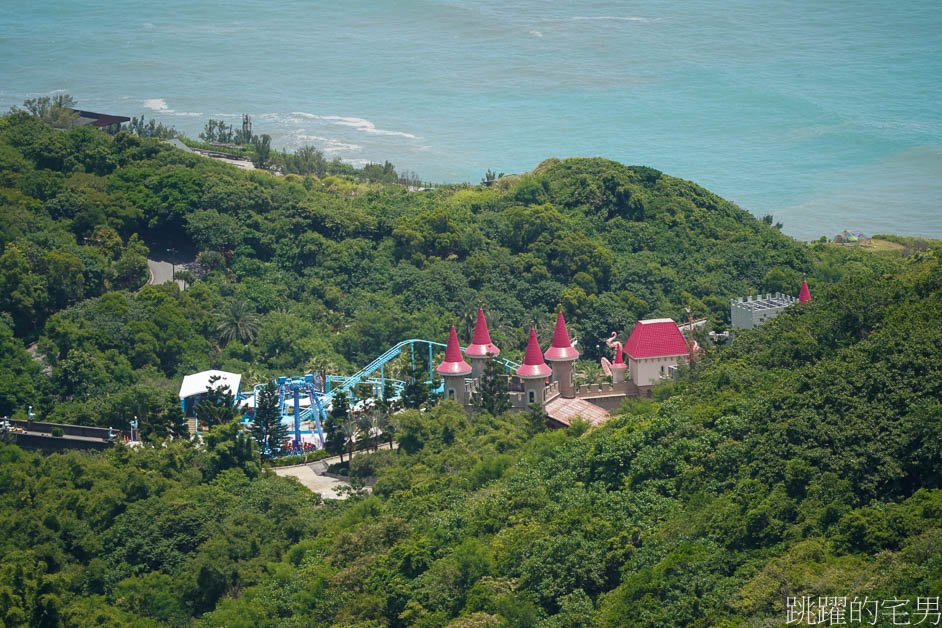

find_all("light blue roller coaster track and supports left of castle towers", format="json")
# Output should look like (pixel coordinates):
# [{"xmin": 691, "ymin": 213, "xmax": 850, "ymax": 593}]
[{"xmin": 253, "ymin": 338, "xmax": 520, "ymax": 447}]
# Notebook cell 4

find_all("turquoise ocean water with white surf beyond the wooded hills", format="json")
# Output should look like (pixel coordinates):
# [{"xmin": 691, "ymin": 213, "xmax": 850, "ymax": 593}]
[{"xmin": 0, "ymin": 0, "xmax": 942, "ymax": 239}]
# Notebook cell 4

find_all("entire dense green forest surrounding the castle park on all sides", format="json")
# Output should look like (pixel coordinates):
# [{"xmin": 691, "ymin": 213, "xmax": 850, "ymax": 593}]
[{"xmin": 0, "ymin": 105, "xmax": 942, "ymax": 627}]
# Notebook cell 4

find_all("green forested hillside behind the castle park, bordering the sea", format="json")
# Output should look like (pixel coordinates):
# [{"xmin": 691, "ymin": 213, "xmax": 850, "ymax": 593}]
[{"xmin": 0, "ymin": 113, "xmax": 873, "ymax": 432}]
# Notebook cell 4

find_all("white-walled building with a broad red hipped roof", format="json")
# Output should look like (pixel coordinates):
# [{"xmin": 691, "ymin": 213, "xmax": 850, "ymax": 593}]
[{"xmin": 624, "ymin": 318, "xmax": 689, "ymax": 386}]
